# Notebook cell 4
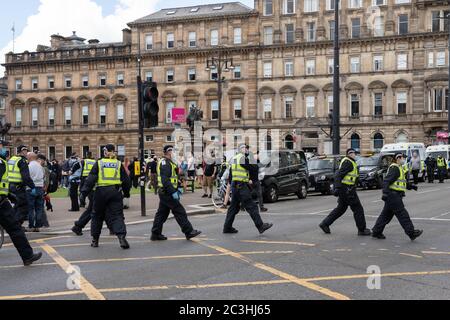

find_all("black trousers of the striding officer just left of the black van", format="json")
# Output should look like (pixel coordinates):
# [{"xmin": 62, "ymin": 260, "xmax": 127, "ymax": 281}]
[{"xmin": 223, "ymin": 182, "xmax": 264, "ymax": 231}]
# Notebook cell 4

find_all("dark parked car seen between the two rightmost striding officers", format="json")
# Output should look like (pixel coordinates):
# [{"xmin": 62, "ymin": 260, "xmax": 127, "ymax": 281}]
[{"xmin": 357, "ymin": 153, "xmax": 394, "ymax": 189}]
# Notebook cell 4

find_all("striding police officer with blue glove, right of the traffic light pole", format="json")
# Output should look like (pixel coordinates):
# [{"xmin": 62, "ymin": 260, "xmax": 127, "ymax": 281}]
[{"xmin": 150, "ymin": 146, "xmax": 202, "ymax": 241}]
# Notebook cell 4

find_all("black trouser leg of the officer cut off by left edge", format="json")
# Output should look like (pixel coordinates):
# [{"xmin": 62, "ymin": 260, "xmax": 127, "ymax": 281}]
[{"xmin": 0, "ymin": 199, "xmax": 33, "ymax": 261}]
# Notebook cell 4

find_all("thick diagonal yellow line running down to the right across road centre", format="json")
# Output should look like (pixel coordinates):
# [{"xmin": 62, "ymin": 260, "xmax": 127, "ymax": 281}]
[{"xmin": 193, "ymin": 239, "xmax": 350, "ymax": 300}]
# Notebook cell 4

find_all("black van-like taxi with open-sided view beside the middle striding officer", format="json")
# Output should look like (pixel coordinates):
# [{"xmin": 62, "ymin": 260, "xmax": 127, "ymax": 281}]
[{"xmin": 260, "ymin": 150, "xmax": 308, "ymax": 203}]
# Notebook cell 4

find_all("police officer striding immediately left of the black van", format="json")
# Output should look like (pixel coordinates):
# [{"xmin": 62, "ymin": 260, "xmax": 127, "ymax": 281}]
[{"xmin": 223, "ymin": 144, "xmax": 273, "ymax": 234}]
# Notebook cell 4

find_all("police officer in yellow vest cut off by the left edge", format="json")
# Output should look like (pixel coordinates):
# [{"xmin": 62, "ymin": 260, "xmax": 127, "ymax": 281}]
[{"xmin": 0, "ymin": 140, "xmax": 42, "ymax": 266}]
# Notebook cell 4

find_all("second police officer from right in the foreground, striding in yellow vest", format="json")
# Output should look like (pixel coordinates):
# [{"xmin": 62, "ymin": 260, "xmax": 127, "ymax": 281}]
[{"xmin": 320, "ymin": 149, "xmax": 371, "ymax": 236}]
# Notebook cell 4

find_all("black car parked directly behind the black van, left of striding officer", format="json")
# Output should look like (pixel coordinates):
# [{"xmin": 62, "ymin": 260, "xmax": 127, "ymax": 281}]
[{"xmin": 308, "ymin": 156, "xmax": 342, "ymax": 195}]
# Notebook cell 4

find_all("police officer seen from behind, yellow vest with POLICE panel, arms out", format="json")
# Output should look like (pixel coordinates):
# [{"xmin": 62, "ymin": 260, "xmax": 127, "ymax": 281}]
[{"xmin": 81, "ymin": 144, "xmax": 131, "ymax": 249}]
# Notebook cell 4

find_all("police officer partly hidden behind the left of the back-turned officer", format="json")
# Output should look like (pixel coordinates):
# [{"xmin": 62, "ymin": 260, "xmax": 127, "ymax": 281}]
[{"xmin": 72, "ymin": 152, "xmax": 97, "ymax": 236}]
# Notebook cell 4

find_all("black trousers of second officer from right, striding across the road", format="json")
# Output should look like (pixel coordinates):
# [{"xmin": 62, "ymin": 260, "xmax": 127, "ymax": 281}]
[{"xmin": 322, "ymin": 185, "xmax": 366, "ymax": 231}]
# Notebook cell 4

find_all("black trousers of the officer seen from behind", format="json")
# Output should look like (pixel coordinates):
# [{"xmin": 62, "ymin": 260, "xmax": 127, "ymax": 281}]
[{"xmin": 91, "ymin": 186, "xmax": 127, "ymax": 239}]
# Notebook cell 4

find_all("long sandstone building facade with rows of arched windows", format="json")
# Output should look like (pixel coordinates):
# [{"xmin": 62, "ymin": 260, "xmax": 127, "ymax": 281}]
[{"xmin": 1, "ymin": 0, "xmax": 450, "ymax": 158}]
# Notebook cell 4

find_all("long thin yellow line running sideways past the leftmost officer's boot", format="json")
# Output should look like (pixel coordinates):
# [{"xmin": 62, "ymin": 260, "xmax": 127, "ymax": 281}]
[{"xmin": 0, "ymin": 247, "xmax": 294, "ymax": 270}]
